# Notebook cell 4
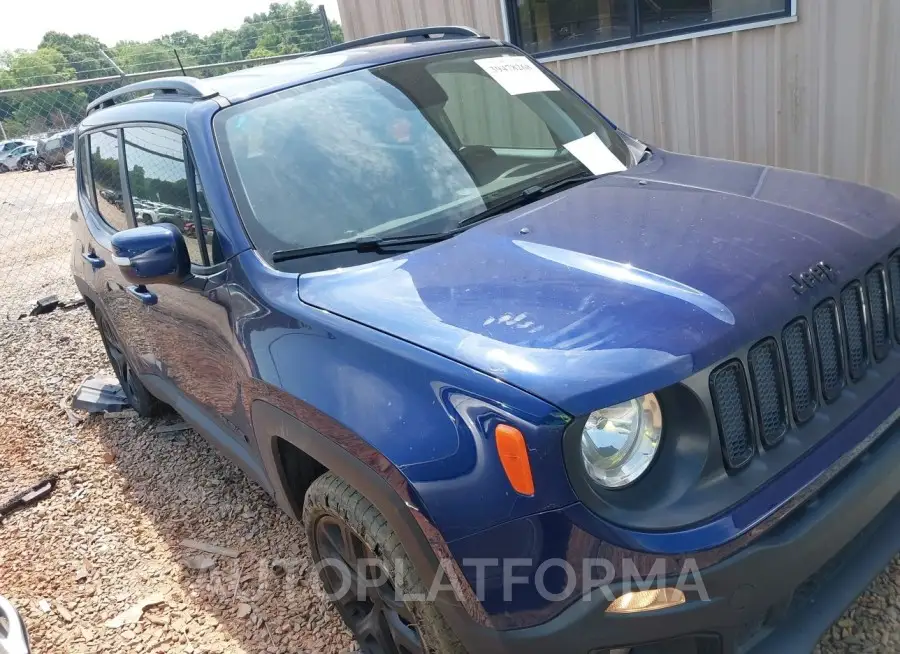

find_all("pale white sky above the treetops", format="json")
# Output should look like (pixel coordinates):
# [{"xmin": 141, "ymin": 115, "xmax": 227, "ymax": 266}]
[{"xmin": 0, "ymin": 0, "xmax": 340, "ymax": 51}]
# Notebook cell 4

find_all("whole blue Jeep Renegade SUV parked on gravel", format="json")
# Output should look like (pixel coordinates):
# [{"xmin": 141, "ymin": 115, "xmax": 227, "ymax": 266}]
[{"xmin": 72, "ymin": 27, "xmax": 900, "ymax": 654}]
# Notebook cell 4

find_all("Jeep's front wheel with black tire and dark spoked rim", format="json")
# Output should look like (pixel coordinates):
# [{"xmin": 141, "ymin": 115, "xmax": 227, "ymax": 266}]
[{"xmin": 303, "ymin": 472, "xmax": 466, "ymax": 654}]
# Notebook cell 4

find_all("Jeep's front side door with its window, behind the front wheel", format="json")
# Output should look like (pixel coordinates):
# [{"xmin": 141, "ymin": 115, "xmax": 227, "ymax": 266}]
[{"xmin": 116, "ymin": 124, "xmax": 254, "ymax": 472}]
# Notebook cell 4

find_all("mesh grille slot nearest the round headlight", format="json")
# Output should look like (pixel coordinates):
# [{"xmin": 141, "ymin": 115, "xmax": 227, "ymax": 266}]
[{"xmin": 709, "ymin": 360, "xmax": 755, "ymax": 468}]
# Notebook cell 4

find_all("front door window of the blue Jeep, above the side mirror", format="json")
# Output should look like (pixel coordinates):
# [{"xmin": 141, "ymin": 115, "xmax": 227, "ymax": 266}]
[{"xmin": 125, "ymin": 127, "xmax": 212, "ymax": 265}]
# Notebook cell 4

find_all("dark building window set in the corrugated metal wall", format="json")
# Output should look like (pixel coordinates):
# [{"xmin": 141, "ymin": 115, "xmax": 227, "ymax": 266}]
[{"xmin": 503, "ymin": 0, "xmax": 792, "ymax": 55}]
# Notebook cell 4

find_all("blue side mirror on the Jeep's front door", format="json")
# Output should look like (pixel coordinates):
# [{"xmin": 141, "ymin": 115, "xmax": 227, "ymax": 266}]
[{"xmin": 112, "ymin": 223, "xmax": 191, "ymax": 284}]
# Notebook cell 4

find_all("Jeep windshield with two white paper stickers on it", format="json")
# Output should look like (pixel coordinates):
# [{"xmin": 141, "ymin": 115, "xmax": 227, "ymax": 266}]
[{"xmin": 215, "ymin": 48, "xmax": 631, "ymax": 260}]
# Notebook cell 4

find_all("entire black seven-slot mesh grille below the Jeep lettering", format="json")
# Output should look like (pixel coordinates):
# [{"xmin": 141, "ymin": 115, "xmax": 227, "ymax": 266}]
[{"xmin": 709, "ymin": 258, "xmax": 900, "ymax": 476}]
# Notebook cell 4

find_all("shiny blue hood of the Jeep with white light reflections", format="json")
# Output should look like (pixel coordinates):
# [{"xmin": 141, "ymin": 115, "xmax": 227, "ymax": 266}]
[{"xmin": 299, "ymin": 151, "xmax": 900, "ymax": 415}]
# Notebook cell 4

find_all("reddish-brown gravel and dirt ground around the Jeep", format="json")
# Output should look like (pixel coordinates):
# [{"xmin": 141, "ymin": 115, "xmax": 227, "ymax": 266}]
[{"xmin": 0, "ymin": 170, "xmax": 900, "ymax": 654}]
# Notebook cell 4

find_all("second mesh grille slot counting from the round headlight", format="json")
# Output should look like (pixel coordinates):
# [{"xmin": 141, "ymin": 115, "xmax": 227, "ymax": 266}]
[{"xmin": 747, "ymin": 339, "xmax": 788, "ymax": 447}]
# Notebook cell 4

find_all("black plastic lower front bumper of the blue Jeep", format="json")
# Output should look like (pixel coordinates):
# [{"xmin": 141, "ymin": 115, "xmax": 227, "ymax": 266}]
[{"xmin": 463, "ymin": 412, "xmax": 900, "ymax": 654}]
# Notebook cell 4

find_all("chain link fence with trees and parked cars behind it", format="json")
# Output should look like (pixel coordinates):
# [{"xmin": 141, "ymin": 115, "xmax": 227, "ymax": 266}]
[{"xmin": 0, "ymin": 0, "xmax": 343, "ymax": 317}]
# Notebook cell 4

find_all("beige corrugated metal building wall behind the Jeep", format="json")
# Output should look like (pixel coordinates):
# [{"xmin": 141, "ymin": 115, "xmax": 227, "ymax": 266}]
[{"xmin": 338, "ymin": 0, "xmax": 900, "ymax": 194}]
